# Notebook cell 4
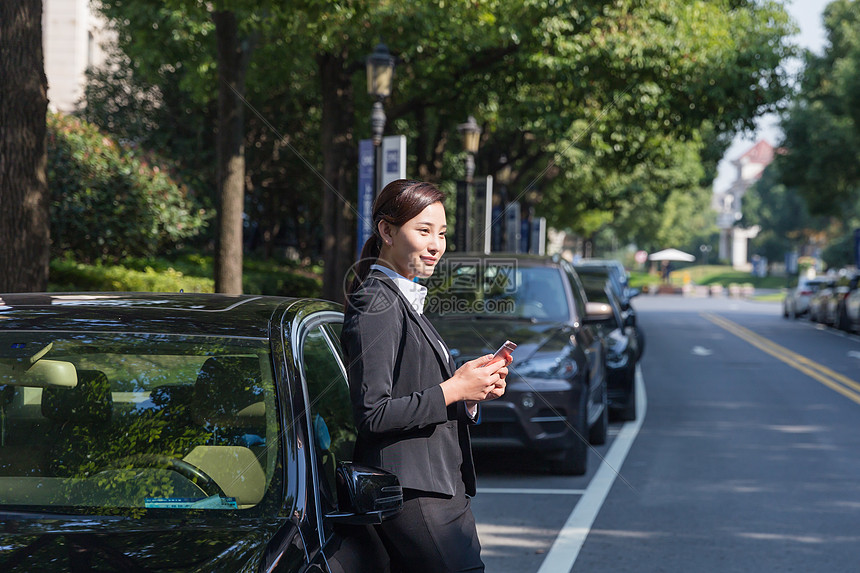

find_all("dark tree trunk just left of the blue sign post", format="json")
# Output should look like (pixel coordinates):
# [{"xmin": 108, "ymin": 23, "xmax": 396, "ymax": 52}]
[{"xmin": 317, "ymin": 53, "xmax": 354, "ymax": 303}]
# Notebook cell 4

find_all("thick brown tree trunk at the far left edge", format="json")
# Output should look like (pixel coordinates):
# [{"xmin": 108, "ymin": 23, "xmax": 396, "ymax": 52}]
[{"xmin": 0, "ymin": 0, "xmax": 50, "ymax": 292}]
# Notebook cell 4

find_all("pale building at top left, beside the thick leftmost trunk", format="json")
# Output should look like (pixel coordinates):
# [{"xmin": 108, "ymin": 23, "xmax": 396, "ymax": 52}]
[{"xmin": 42, "ymin": 0, "xmax": 106, "ymax": 113}]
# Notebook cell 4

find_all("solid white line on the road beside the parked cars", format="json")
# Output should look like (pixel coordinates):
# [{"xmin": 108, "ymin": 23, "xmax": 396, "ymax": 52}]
[{"xmin": 538, "ymin": 366, "xmax": 648, "ymax": 573}]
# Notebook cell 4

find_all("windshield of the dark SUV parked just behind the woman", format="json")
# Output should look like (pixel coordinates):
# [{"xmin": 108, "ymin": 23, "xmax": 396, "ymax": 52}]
[{"xmin": 426, "ymin": 260, "xmax": 570, "ymax": 322}]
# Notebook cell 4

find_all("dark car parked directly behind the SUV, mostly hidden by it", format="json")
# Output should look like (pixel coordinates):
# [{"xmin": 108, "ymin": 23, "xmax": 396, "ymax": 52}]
[{"xmin": 581, "ymin": 275, "xmax": 639, "ymax": 421}]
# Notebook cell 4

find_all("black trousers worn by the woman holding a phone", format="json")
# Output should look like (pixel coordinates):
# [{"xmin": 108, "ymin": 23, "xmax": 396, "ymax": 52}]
[{"xmin": 378, "ymin": 483, "xmax": 484, "ymax": 573}]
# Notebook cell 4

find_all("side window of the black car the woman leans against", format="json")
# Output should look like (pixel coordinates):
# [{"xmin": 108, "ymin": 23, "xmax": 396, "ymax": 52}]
[{"xmin": 302, "ymin": 325, "xmax": 357, "ymax": 512}]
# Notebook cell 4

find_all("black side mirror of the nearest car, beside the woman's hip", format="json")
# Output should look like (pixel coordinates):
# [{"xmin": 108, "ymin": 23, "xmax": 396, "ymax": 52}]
[{"xmin": 326, "ymin": 462, "xmax": 403, "ymax": 525}]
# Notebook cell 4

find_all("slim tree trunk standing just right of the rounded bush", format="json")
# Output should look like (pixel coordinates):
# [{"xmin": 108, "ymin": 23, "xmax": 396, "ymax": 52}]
[{"xmin": 212, "ymin": 12, "xmax": 251, "ymax": 294}]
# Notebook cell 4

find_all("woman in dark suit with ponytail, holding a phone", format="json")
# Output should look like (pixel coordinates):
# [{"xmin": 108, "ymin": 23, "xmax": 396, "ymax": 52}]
[{"xmin": 341, "ymin": 179, "xmax": 511, "ymax": 573}]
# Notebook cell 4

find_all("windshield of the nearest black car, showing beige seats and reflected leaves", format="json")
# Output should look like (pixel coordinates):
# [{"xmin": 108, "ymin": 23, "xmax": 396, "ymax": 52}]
[{"xmin": 0, "ymin": 332, "xmax": 279, "ymax": 514}]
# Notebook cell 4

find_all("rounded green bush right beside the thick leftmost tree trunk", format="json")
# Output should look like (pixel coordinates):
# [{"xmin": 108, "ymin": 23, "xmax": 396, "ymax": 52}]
[{"xmin": 47, "ymin": 114, "xmax": 207, "ymax": 262}]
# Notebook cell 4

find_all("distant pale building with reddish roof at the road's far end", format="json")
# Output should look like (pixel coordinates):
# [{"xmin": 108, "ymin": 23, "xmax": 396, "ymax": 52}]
[{"xmin": 713, "ymin": 140, "xmax": 776, "ymax": 270}]
